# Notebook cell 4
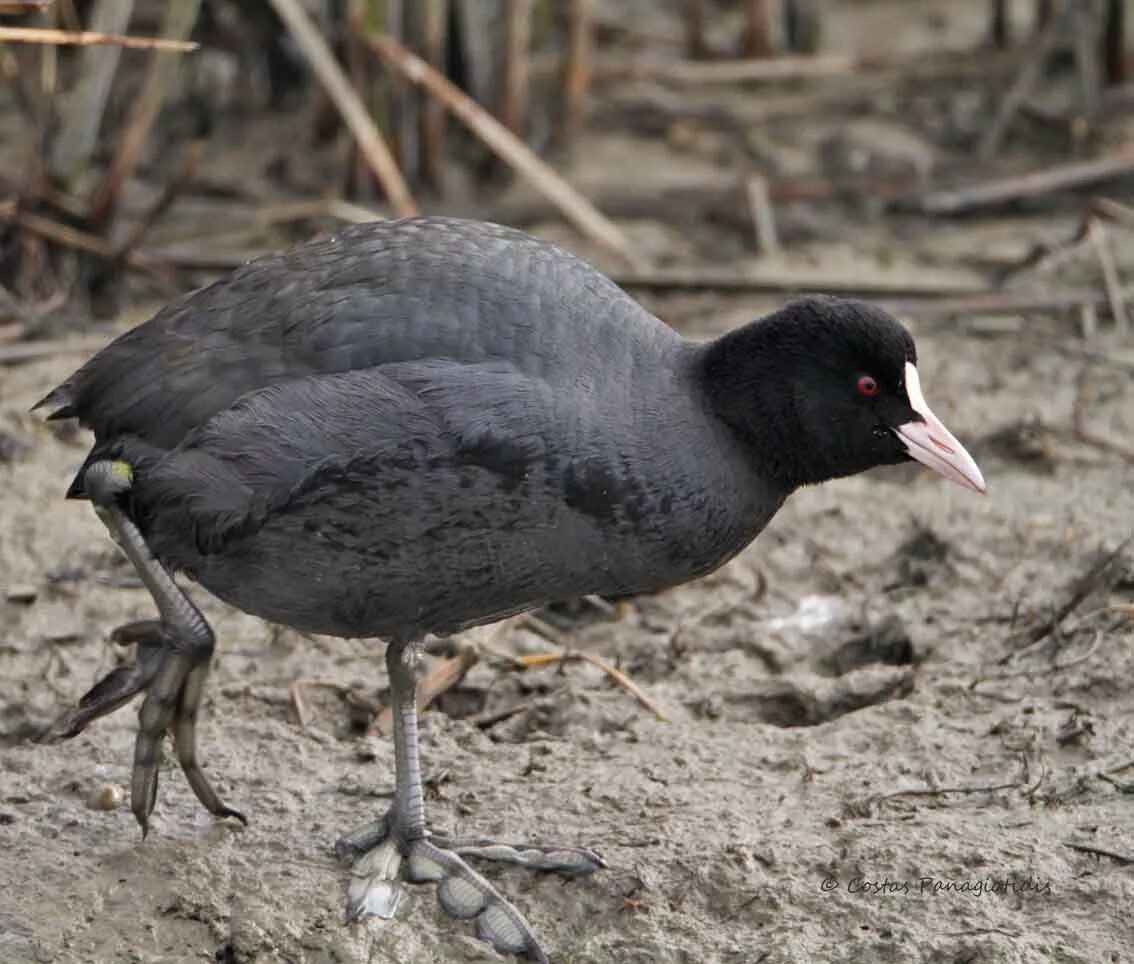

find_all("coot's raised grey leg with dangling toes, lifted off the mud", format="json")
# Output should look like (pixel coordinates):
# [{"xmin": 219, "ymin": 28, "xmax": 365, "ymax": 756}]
[{"xmin": 46, "ymin": 462, "xmax": 247, "ymax": 835}]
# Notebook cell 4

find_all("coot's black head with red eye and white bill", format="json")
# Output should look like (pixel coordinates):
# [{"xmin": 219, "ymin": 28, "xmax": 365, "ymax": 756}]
[{"xmin": 700, "ymin": 297, "xmax": 984, "ymax": 492}]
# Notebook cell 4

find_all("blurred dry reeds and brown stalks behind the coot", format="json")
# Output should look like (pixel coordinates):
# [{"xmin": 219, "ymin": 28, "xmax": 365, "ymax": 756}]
[{"xmin": 0, "ymin": 0, "xmax": 1134, "ymax": 351}]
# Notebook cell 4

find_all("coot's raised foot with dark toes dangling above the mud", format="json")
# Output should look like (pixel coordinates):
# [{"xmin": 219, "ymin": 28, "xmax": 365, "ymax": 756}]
[{"xmin": 41, "ymin": 619, "xmax": 247, "ymax": 834}]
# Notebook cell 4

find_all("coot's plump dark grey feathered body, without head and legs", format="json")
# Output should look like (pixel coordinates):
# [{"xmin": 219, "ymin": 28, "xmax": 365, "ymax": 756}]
[{"xmin": 39, "ymin": 219, "xmax": 784, "ymax": 635}]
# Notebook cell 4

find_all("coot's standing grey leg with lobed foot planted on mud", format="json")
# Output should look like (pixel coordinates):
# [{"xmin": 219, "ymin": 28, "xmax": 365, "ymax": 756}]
[{"xmin": 337, "ymin": 643, "xmax": 604, "ymax": 962}]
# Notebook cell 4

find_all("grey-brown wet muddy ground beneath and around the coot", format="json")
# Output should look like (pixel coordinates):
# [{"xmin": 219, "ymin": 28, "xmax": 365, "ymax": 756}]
[{"xmin": 0, "ymin": 3, "xmax": 1134, "ymax": 964}]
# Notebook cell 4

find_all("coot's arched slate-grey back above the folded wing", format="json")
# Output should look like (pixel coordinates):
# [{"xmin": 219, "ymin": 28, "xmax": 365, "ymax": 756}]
[{"xmin": 42, "ymin": 218, "xmax": 679, "ymax": 476}]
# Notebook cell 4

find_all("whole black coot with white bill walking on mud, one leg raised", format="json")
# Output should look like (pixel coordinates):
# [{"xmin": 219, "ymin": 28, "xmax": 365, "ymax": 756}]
[{"xmin": 43, "ymin": 218, "xmax": 984, "ymax": 959}]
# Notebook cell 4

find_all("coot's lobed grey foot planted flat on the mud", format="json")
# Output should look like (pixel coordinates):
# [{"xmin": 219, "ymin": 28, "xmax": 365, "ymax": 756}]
[{"xmin": 336, "ymin": 809, "xmax": 607, "ymax": 962}]
